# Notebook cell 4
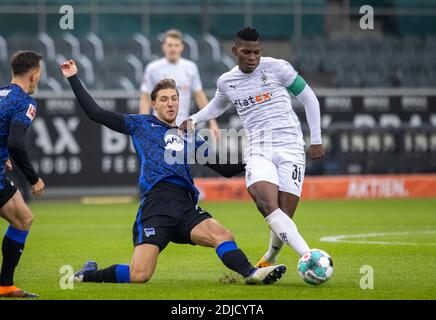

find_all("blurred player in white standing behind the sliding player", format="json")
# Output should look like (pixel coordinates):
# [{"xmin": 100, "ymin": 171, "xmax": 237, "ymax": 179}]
[{"xmin": 139, "ymin": 29, "xmax": 219, "ymax": 137}]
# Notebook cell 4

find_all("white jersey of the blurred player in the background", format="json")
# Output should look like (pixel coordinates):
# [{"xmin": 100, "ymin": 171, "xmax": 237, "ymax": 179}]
[{"xmin": 141, "ymin": 58, "xmax": 203, "ymax": 125}]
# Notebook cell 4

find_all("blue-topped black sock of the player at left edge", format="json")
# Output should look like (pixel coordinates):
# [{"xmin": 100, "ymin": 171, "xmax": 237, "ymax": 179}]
[{"xmin": 0, "ymin": 225, "xmax": 29, "ymax": 286}]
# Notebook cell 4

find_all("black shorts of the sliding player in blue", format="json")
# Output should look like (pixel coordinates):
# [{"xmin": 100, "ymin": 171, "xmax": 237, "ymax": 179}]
[{"xmin": 133, "ymin": 182, "xmax": 212, "ymax": 251}]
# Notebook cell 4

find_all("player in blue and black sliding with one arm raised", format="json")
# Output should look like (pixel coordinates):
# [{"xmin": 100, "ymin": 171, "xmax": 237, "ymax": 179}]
[{"xmin": 61, "ymin": 60, "xmax": 286, "ymax": 284}]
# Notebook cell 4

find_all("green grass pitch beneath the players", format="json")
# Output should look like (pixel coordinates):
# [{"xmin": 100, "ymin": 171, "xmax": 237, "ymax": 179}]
[{"xmin": 0, "ymin": 199, "xmax": 436, "ymax": 300}]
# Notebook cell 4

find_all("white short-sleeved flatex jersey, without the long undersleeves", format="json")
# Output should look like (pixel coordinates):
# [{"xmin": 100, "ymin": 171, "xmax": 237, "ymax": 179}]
[{"xmin": 215, "ymin": 57, "xmax": 304, "ymax": 150}]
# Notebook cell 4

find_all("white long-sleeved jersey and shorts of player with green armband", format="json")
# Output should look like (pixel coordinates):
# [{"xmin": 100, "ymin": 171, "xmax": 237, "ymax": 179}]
[{"xmin": 189, "ymin": 58, "xmax": 322, "ymax": 197}]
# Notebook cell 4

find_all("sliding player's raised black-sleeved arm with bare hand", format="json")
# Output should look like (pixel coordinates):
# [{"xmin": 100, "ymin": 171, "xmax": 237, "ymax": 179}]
[{"xmin": 60, "ymin": 60, "xmax": 125, "ymax": 133}]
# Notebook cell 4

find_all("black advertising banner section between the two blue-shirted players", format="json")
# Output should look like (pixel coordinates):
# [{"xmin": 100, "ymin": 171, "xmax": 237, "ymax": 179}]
[{"xmin": 27, "ymin": 98, "xmax": 139, "ymax": 187}]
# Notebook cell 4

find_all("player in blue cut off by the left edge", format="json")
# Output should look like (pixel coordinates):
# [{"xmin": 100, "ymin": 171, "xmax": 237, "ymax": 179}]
[{"xmin": 0, "ymin": 51, "xmax": 44, "ymax": 298}]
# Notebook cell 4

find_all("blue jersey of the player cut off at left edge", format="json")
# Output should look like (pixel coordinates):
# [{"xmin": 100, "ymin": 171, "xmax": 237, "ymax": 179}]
[{"xmin": 0, "ymin": 84, "xmax": 37, "ymax": 190}]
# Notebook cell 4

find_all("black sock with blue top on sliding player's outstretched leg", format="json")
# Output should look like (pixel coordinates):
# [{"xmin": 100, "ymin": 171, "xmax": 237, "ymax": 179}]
[{"xmin": 216, "ymin": 241, "xmax": 255, "ymax": 278}]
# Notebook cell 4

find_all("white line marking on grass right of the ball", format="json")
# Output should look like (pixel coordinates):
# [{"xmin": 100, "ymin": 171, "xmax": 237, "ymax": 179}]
[{"xmin": 319, "ymin": 230, "xmax": 436, "ymax": 246}]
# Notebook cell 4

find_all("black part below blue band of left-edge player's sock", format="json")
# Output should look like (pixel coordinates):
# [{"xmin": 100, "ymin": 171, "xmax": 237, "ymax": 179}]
[{"xmin": 0, "ymin": 236, "xmax": 24, "ymax": 286}]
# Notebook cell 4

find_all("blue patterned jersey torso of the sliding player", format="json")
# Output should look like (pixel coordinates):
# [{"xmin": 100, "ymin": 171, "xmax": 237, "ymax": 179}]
[{"xmin": 124, "ymin": 114, "xmax": 207, "ymax": 202}]
